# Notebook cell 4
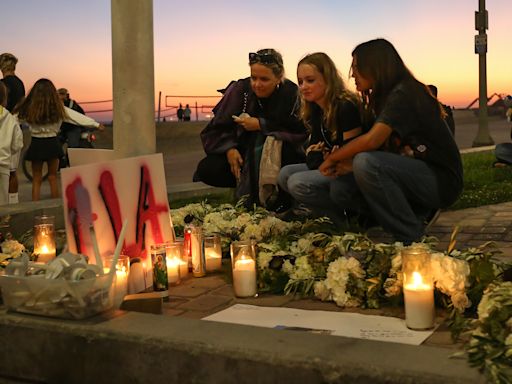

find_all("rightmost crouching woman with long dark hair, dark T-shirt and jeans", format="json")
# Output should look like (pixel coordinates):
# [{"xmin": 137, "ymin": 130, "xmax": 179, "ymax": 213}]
[{"xmin": 319, "ymin": 39, "xmax": 463, "ymax": 244}]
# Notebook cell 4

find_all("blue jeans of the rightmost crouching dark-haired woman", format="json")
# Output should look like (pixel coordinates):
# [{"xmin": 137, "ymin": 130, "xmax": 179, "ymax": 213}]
[{"xmin": 352, "ymin": 151, "xmax": 440, "ymax": 244}]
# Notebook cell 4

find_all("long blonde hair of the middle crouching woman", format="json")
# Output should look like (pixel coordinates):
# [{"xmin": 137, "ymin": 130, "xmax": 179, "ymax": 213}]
[{"xmin": 297, "ymin": 52, "xmax": 360, "ymax": 137}]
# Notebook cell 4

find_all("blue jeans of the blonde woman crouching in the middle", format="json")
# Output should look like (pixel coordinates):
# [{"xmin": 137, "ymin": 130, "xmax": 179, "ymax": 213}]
[{"xmin": 278, "ymin": 164, "xmax": 357, "ymax": 226}]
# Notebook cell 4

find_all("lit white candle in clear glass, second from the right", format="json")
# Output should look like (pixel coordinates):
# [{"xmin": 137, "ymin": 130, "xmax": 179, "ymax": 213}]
[{"xmin": 231, "ymin": 241, "xmax": 257, "ymax": 297}]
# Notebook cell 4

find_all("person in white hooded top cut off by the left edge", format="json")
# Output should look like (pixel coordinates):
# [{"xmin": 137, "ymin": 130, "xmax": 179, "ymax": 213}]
[{"xmin": 0, "ymin": 82, "xmax": 23, "ymax": 205}]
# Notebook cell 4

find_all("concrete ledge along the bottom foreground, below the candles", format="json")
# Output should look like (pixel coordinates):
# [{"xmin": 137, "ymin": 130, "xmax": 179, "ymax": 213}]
[{"xmin": 0, "ymin": 311, "xmax": 485, "ymax": 384}]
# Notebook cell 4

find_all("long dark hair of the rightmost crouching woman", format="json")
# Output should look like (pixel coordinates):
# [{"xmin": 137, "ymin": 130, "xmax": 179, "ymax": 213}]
[{"xmin": 352, "ymin": 39, "xmax": 445, "ymax": 118}]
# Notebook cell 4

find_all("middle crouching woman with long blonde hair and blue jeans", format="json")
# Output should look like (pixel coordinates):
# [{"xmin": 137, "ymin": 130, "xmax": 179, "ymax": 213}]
[{"xmin": 279, "ymin": 52, "xmax": 363, "ymax": 225}]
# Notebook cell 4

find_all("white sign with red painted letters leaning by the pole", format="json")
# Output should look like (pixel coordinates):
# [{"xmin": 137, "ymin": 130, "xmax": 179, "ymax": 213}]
[{"xmin": 61, "ymin": 149, "xmax": 175, "ymax": 265}]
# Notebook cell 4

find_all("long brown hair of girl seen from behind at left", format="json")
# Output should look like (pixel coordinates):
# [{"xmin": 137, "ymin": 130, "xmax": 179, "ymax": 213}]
[{"xmin": 14, "ymin": 79, "xmax": 65, "ymax": 125}]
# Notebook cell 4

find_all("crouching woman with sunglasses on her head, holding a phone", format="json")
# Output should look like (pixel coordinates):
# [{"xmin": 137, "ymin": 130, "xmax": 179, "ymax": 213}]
[{"xmin": 194, "ymin": 49, "xmax": 307, "ymax": 209}]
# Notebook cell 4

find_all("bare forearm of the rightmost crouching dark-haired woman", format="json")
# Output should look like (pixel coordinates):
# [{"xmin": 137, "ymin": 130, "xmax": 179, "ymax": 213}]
[{"xmin": 318, "ymin": 123, "xmax": 393, "ymax": 176}]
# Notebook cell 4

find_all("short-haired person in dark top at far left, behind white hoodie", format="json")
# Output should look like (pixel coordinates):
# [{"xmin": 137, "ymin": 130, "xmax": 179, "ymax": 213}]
[{"xmin": 0, "ymin": 52, "xmax": 25, "ymax": 204}]
